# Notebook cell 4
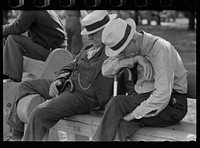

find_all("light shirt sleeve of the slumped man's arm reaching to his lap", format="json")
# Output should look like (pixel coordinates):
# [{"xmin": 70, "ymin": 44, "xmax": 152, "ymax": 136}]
[{"xmin": 132, "ymin": 46, "xmax": 175, "ymax": 119}]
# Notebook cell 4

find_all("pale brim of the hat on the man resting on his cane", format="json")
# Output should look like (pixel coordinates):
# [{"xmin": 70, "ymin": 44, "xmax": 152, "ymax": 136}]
[{"xmin": 105, "ymin": 18, "xmax": 136, "ymax": 57}]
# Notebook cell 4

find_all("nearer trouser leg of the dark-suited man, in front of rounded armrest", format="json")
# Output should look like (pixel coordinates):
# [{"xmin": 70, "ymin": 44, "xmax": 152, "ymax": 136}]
[{"xmin": 22, "ymin": 91, "xmax": 96, "ymax": 141}]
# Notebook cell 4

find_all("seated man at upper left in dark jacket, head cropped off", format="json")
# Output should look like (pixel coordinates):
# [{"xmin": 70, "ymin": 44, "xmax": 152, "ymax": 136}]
[{"xmin": 3, "ymin": 10, "xmax": 67, "ymax": 82}]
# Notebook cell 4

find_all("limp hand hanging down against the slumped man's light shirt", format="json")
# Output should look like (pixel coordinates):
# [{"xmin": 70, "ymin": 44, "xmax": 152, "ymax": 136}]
[{"xmin": 134, "ymin": 56, "xmax": 153, "ymax": 80}]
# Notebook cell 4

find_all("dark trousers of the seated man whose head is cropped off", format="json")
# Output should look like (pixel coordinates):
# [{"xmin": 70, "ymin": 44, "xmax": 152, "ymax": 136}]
[{"xmin": 3, "ymin": 35, "xmax": 50, "ymax": 81}]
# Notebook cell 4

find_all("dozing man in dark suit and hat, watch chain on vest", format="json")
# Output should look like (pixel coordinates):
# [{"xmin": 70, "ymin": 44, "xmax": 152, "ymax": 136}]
[{"xmin": 8, "ymin": 10, "xmax": 119, "ymax": 141}]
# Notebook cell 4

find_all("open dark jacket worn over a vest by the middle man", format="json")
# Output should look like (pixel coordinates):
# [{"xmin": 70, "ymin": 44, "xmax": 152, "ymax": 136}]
[{"xmin": 56, "ymin": 46, "xmax": 113, "ymax": 107}]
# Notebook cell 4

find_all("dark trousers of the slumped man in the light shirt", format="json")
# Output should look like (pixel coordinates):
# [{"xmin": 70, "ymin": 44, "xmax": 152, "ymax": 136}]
[{"xmin": 93, "ymin": 92, "xmax": 187, "ymax": 141}]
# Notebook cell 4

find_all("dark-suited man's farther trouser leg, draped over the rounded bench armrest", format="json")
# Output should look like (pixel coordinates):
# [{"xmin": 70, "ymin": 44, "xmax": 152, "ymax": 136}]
[{"xmin": 7, "ymin": 79, "xmax": 53, "ymax": 132}]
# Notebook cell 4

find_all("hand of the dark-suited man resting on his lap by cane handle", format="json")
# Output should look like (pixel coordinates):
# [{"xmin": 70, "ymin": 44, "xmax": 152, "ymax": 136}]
[{"xmin": 49, "ymin": 80, "xmax": 62, "ymax": 97}]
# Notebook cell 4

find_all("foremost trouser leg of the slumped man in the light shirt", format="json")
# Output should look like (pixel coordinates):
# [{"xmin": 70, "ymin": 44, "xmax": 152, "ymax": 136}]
[{"xmin": 93, "ymin": 95, "xmax": 147, "ymax": 141}]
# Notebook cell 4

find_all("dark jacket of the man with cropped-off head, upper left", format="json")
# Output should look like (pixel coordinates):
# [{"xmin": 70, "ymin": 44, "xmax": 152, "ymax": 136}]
[{"xmin": 3, "ymin": 10, "xmax": 67, "ymax": 49}]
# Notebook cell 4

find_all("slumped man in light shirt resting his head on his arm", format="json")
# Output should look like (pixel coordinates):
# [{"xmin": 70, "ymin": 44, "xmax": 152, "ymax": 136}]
[{"xmin": 93, "ymin": 19, "xmax": 187, "ymax": 141}]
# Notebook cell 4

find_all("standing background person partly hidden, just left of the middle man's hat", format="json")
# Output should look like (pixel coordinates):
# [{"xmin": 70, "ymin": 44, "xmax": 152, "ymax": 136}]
[{"xmin": 63, "ymin": 10, "xmax": 83, "ymax": 57}]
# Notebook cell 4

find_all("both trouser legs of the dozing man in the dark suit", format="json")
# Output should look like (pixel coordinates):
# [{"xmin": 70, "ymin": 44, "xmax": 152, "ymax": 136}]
[{"xmin": 7, "ymin": 79, "xmax": 98, "ymax": 141}]
